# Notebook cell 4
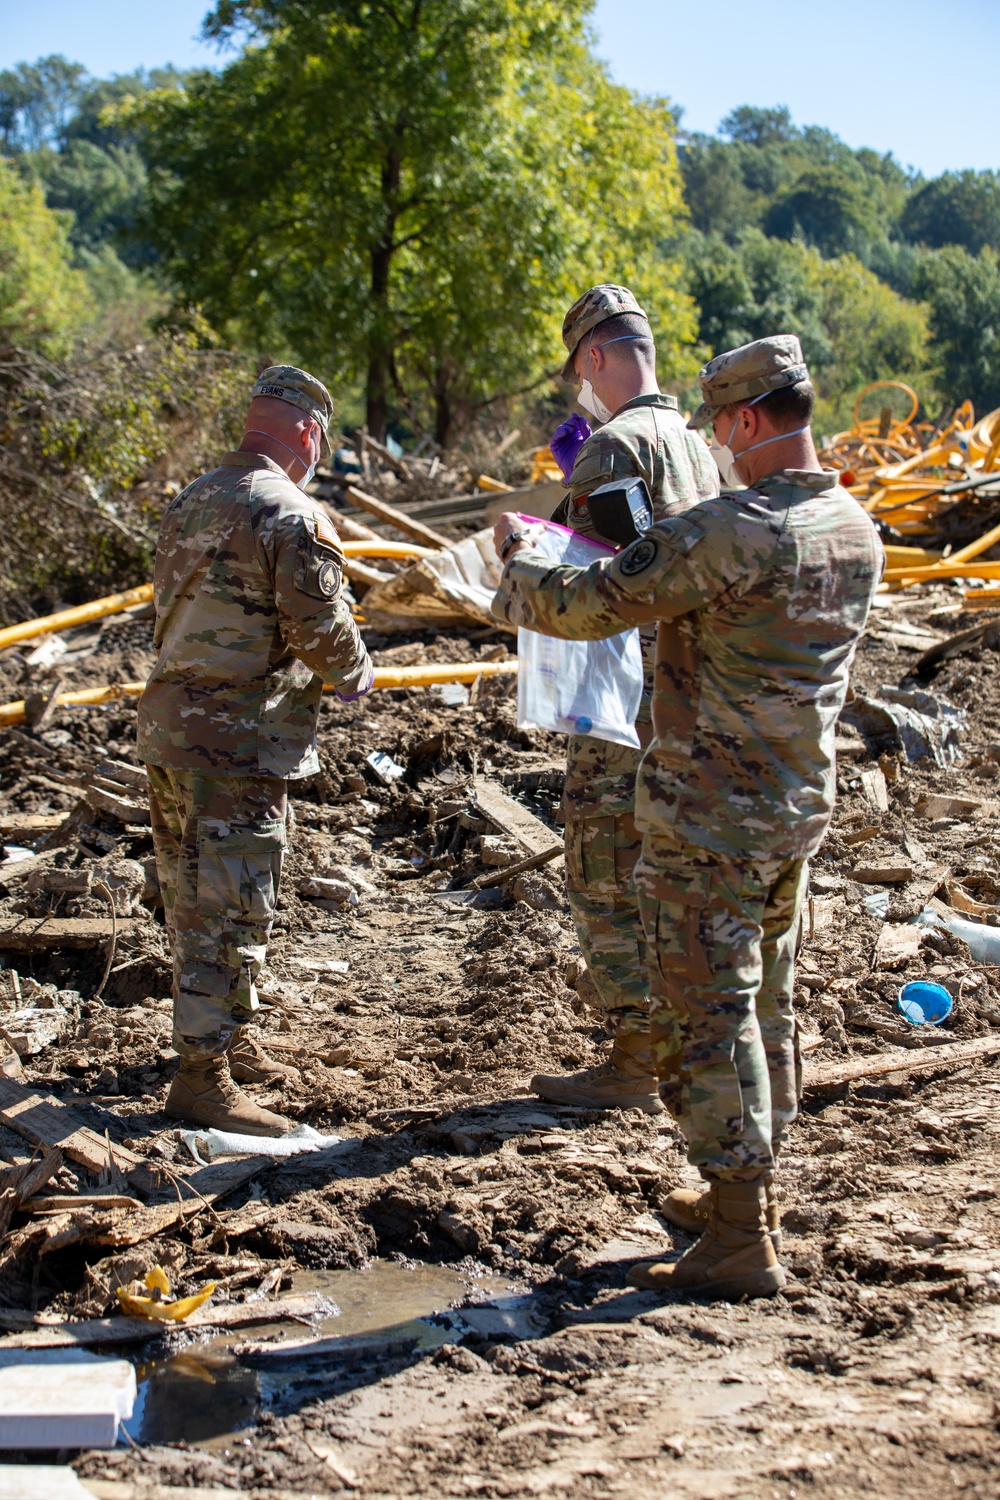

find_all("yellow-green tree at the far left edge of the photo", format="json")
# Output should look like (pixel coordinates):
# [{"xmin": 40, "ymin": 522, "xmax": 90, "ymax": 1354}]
[{"xmin": 0, "ymin": 158, "xmax": 87, "ymax": 354}]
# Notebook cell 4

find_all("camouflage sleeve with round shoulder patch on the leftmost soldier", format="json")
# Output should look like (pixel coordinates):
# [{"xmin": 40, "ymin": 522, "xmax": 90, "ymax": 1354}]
[{"xmin": 268, "ymin": 513, "xmax": 375, "ymax": 702}]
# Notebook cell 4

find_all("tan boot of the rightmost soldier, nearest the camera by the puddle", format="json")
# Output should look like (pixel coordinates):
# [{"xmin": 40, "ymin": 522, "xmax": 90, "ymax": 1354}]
[{"xmin": 628, "ymin": 1179, "xmax": 784, "ymax": 1302}]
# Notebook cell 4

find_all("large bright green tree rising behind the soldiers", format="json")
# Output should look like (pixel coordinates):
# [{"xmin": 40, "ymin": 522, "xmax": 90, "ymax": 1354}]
[{"xmin": 126, "ymin": 0, "xmax": 693, "ymax": 443}]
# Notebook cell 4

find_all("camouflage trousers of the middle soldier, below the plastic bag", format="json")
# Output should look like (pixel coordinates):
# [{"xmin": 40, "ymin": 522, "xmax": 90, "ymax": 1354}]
[{"xmin": 564, "ymin": 735, "xmax": 649, "ymax": 1035}]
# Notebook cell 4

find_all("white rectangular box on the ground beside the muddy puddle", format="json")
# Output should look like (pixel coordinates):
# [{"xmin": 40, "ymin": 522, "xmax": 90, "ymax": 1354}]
[{"xmin": 0, "ymin": 1349, "xmax": 135, "ymax": 1452}]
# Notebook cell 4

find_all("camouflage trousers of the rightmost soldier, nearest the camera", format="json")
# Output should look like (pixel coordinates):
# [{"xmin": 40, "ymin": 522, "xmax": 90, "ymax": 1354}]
[{"xmin": 636, "ymin": 834, "xmax": 808, "ymax": 1182}]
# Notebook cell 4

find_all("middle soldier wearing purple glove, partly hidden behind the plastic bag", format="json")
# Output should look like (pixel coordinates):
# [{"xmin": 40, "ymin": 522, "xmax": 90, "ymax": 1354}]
[{"xmin": 531, "ymin": 285, "xmax": 718, "ymax": 1113}]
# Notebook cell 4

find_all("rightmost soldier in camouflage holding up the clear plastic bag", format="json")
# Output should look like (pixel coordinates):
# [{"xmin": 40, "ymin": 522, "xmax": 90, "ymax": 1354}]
[{"xmin": 493, "ymin": 335, "xmax": 885, "ymax": 1296}]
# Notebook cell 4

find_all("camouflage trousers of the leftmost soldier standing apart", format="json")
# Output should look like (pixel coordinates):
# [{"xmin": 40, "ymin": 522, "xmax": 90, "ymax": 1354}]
[{"xmin": 145, "ymin": 765, "xmax": 288, "ymax": 1058}]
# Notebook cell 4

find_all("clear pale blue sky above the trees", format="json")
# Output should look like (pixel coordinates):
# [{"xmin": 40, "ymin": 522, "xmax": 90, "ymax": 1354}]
[{"xmin": 0, "ymin": 0, "xmax": 1000, "ymax": 176}]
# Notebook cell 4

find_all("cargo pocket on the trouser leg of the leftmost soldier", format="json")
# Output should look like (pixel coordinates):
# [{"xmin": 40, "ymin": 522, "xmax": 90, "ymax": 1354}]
[{"xmin": 198, "ymin": 818, "xmax": 285, "ymax": 924}]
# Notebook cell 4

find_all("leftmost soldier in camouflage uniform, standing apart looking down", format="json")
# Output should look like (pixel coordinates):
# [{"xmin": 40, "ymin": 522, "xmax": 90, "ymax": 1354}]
[{"xmin": 138, "ymin": 366, "xmax": 373, "ymax": 1136}]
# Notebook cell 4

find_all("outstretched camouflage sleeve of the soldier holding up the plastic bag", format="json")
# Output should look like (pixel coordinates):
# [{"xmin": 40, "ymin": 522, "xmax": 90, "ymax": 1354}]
[{"xmin": 493, "ymin": 503, "xmax": 758, "ymax": 641}]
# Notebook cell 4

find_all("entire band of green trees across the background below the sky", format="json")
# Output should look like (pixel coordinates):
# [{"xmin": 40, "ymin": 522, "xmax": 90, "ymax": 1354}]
[{"xmin": 0, "ymin": 38, "xmax": 1000, "ymax": 444}]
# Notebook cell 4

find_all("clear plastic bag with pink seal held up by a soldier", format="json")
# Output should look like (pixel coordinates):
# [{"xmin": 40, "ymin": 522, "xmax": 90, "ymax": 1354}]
[{"xmin": 517, "ymin": 516, "xmax": 643, "ymax": 749}]
